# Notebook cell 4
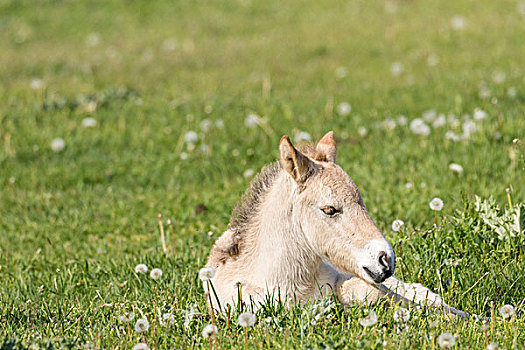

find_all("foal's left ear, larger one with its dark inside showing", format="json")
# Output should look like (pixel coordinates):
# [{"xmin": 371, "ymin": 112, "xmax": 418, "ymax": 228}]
[{"xmin": 279, "ymin": 135, "xmax": 314, "ymax": 183}]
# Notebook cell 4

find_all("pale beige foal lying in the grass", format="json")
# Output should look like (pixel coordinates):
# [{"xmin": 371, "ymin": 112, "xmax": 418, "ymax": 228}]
[{"xmin": 206, "ymin": 131, "xmax": 465, "ymax": 316}]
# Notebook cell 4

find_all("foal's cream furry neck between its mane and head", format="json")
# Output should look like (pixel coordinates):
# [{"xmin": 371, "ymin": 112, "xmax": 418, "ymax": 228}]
[{"xmin": 246, "ymin": 173, "xmax": 320, "ymax": 294}]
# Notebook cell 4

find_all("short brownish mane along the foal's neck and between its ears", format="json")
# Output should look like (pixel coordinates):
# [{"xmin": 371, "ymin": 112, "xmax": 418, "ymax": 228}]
[{"xmin": 219, "ymin": 144, "xmax": 326, "ymax": 258}]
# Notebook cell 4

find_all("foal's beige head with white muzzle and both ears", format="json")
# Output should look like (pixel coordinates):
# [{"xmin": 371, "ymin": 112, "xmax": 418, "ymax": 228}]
[{"xmin": 279, "ymin": 132, "xmax": 395, "ymax": 283}]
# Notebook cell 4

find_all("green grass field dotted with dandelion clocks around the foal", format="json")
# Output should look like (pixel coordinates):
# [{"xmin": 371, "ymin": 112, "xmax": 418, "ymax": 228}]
[{"xmin": 0, "ymin": 0, "xmax": 525, "ymax": 349}]
